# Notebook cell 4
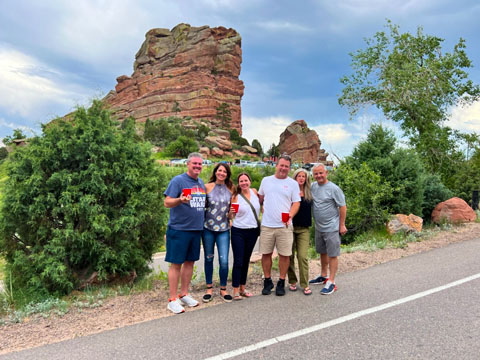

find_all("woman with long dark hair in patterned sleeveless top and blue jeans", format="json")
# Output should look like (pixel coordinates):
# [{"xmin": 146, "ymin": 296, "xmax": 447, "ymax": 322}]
[{"xmin": 202, "ymin": 163, "xmax": 234, "ymax": 302}]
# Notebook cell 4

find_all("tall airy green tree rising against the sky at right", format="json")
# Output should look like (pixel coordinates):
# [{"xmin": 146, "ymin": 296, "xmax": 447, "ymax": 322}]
[{"xmin": 338, "ymin": 21, "xmax": 480, "ymax": 170}]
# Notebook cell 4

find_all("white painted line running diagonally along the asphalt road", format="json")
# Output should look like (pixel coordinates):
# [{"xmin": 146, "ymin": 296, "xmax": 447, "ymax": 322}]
[{"xmin": 205, "ymin": 273, "xmax": 480, "ymax": 360}]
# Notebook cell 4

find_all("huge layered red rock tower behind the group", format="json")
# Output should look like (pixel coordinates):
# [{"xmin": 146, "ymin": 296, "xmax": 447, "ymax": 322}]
[{"xmin": 104, "ymin": 24, "xmax": 244, "ymax": 134}]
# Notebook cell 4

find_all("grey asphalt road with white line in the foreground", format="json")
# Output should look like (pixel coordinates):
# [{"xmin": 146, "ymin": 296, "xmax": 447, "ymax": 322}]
[{"xmin": 0, "ymin": 239, "xmax": 480, "ymax": 360}]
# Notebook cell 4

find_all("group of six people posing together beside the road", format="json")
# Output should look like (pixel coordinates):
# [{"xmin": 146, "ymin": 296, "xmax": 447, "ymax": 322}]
[{"xmin": 164, "ymin": 153, "xmax": 347, "ymax": 314}]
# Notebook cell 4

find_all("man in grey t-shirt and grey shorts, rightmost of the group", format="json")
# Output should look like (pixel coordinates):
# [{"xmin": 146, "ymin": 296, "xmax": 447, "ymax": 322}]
[{"xmin": 309, "ymin": 164, "xmax": 347, "ymax": 295}]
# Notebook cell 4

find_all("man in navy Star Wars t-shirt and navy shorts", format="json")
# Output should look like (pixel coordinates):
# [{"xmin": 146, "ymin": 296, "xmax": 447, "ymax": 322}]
[{"xmin": 164, "ymin": 153, "xmax": 205, "ymax": 314}]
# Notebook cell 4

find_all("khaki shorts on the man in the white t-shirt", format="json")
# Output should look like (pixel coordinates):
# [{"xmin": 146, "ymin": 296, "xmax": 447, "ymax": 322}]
[{"xmin": 260, "ymin": 225, "xmax": 293, "ymax": 256}]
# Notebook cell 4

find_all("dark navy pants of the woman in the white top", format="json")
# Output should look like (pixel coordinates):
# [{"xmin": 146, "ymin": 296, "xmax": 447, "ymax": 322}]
[{"xmin": 230, "ymin": 226, "xmax": 260, "ymax": 288}]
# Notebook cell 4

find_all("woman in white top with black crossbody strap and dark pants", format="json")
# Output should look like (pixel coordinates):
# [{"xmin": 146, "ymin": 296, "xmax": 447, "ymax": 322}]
[{"xmin": 231, "ymin": 173, "xmax": 260, "ymax": 300}]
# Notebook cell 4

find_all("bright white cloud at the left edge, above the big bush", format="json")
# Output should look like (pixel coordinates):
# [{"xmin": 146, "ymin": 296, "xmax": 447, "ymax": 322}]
[{"xmin": 0, "ymin": 47, "xmax": 91, "ymax": 117}]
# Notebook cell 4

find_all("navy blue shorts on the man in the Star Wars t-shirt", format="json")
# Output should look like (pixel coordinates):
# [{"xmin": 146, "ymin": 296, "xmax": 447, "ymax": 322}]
[{"xmin": 165, "ymin": 227, "xmax": 202, "ymax": 264}]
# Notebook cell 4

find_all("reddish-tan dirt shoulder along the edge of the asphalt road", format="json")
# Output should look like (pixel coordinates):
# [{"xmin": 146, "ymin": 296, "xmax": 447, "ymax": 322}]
[{"xmin": 0, "ymin": 223, "xmax": 480, "ymax": 354}]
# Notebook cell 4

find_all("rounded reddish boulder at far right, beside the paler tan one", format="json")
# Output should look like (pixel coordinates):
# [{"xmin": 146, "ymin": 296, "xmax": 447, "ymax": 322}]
[{"xmin": 432, "ymin": 197, "xmax": 477, "ymax": 224}]
